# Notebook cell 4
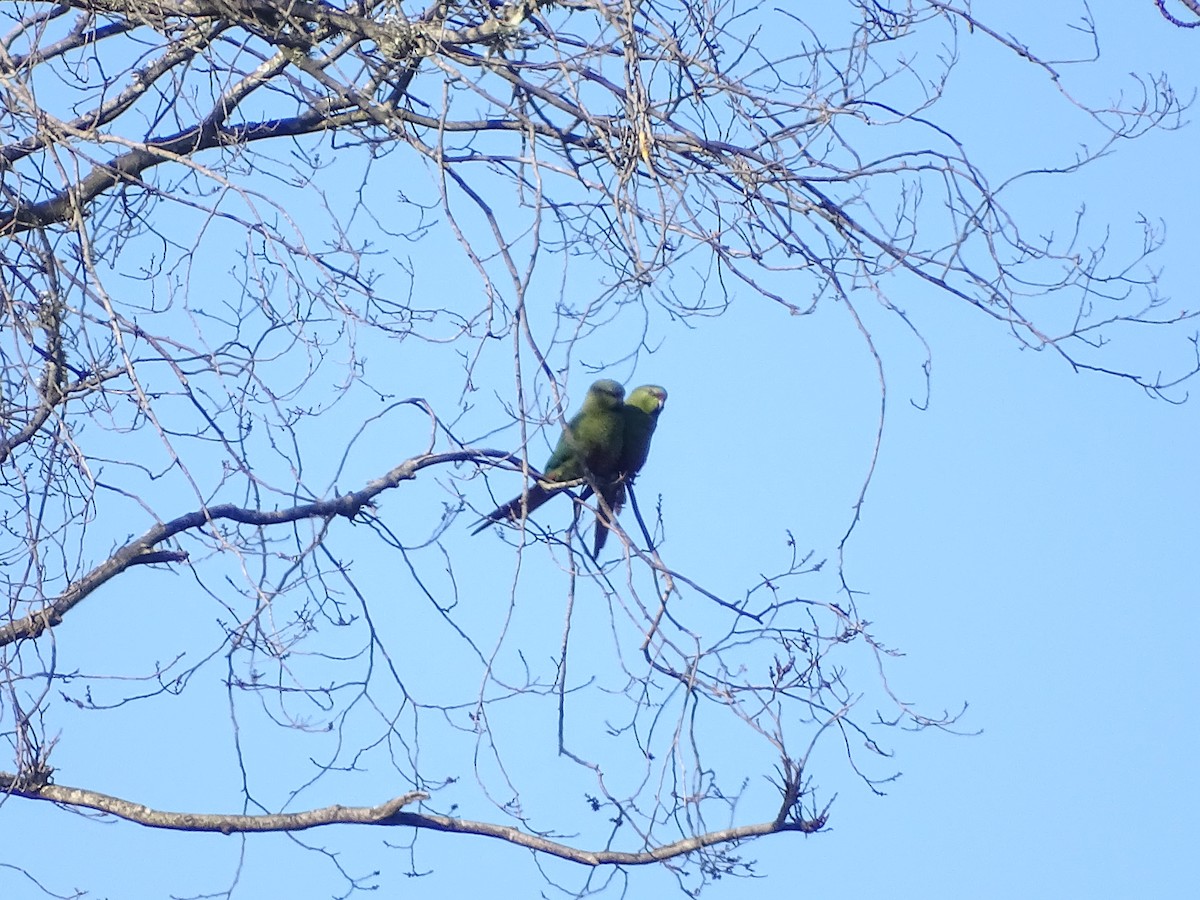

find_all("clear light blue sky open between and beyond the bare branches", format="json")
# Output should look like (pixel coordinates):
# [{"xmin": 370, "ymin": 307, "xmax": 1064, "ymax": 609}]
[{"xmin": 0, "ymin": 0, "xmax": 1200, "ymax": 900}]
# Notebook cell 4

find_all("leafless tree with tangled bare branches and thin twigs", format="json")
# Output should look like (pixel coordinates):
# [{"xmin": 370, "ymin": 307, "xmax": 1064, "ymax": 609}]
[{"xmin": 0, "ymin": 0, "xmax": 1200, "ymax": 889}]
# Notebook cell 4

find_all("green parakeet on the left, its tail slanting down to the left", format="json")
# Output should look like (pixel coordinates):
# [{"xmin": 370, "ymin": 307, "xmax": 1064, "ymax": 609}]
[{"xmin": 472, "ymin": 378, "xmax": 625, "ymax": 534}]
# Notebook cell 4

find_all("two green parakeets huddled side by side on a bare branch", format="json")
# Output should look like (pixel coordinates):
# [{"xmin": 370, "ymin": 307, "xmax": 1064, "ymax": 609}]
[{"xmin": 472, "ymin": 378, "xmax": 667, "ymax": 556}]
